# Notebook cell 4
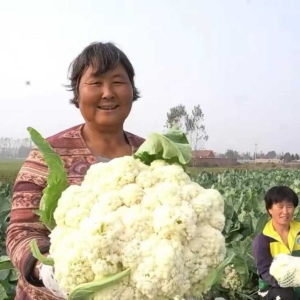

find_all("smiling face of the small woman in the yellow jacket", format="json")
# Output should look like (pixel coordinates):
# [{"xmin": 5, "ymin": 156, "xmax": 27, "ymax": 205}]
[{"xmin": 269, "ymin": 201, "xmax": 295, "ymax": 225}]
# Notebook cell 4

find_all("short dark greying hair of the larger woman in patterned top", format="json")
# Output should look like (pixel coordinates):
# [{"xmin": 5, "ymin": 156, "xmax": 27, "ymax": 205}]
[{"xmin": 66, "ymin": 42, "xmax": 140, "ymax": 108}]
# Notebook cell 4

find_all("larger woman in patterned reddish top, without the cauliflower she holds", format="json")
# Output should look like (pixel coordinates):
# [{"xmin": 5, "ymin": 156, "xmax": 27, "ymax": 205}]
[{"xmin": 7, "ymin": 43, "xmax": 144, "ymax": 300}]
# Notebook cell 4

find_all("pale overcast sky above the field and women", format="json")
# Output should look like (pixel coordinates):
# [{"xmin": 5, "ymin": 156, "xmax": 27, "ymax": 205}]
[{"xmin": 0, "ymin": 0, "xmax": 300, "ymax": 153}]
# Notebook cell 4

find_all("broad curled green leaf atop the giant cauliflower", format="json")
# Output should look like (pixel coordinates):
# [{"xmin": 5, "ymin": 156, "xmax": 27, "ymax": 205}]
[{"xmin": 134, "ymin": 129, "xmax": 192, "ymax": 166}]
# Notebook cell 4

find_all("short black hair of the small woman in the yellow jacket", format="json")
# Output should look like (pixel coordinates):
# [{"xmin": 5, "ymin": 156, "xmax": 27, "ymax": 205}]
[{"xmin": 265, "ymin": 185, "xmax": 299, "ymax": 210}]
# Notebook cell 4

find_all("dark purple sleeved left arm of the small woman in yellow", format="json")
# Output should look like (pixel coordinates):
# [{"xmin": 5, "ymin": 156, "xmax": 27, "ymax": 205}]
[{"xmin": 253, "ymin": 234, "xmax": 279, "ymax": 287}]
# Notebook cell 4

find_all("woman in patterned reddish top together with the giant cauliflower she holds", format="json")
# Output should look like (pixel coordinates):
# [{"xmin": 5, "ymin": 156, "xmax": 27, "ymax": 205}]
[{"xmin": 7, "ymin": 43, "xmax": 226, "ymax": 300}]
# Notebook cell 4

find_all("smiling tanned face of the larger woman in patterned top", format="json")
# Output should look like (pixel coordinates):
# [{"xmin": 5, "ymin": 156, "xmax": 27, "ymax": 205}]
[{"xmin": 78, "ymin": 65, "xmax": 133, "ymax": 128}]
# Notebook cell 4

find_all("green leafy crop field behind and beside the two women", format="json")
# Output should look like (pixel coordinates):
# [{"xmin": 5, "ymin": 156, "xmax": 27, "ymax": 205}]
[{"xmin": 0, "ymin": 169, "xmax": 300, "ymax": 300}]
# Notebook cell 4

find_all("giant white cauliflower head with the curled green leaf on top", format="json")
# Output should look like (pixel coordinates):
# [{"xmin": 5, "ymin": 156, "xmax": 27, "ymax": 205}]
[{"xmin": 28, "ymin": 130, "xmax": 226, "ymax": 300}]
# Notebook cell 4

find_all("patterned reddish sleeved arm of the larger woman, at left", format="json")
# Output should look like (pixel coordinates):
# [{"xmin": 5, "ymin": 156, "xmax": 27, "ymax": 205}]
[{"xmin": 6, "ymin": 149, "xmax": 50, "ymax": 286}]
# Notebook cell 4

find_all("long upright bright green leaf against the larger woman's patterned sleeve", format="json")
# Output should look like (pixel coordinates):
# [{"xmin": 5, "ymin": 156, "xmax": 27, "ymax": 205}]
[{"xmin": 27, "ymin": 127, "xmax": 68, "ymax": 230}]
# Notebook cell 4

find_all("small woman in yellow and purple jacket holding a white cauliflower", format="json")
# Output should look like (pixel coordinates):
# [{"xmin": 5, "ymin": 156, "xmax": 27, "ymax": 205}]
[{"xmin": 253, "ymin": 186, "xmax": 300, "ymax": 300}]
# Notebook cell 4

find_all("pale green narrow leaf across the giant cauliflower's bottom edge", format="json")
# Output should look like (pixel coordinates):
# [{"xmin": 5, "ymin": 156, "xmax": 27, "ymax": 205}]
[{"xmin": 68, "ymin": 269, "xmax": 130, "ymax": 300}]
